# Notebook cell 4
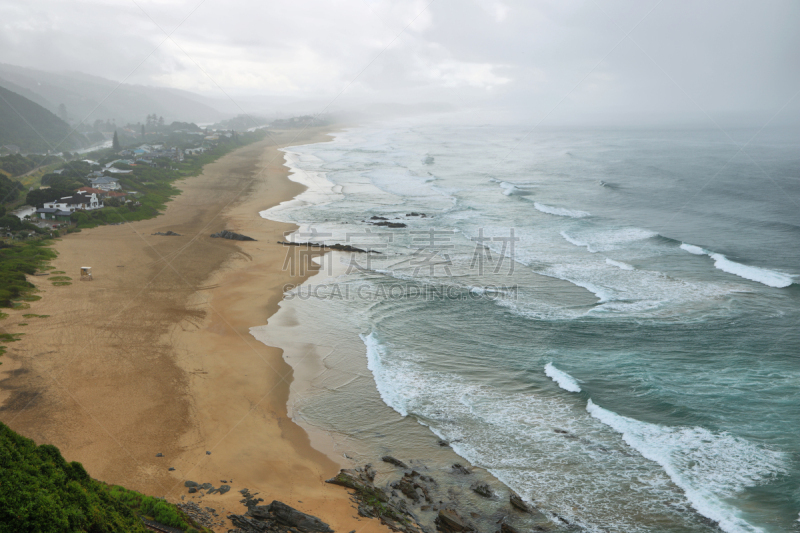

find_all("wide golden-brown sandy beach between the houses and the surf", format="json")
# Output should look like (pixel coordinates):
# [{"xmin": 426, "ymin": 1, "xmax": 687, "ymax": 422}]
[{"xmin": 0, "ymin": 130, "xmax": 388, "ymax": 533}]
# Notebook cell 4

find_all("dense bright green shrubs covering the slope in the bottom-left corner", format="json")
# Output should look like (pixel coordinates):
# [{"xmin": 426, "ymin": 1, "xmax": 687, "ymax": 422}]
[{"xmin": 0, "ymin": 423, "xmax": 201, "ymax": 533}]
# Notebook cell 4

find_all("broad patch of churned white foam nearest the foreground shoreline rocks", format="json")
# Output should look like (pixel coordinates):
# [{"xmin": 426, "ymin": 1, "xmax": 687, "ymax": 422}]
[{"xmin": 361, "ymin": 332, "xmax": 716, "ymax": 533}]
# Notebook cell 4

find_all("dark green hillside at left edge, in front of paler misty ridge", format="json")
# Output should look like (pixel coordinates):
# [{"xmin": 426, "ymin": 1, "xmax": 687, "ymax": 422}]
[{"xmin": 0, "ymin": 83, "xmax": 87, "ymax": 152}]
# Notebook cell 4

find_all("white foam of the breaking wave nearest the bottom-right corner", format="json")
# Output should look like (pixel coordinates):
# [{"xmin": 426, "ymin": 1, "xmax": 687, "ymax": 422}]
[{"xmin": 586, "ymin": 400, "xmax": 786, "ymax": 533}]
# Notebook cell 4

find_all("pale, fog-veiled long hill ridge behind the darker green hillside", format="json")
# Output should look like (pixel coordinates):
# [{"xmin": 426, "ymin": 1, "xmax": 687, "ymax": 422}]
[{"xmin": 0, "ymin": 63, "xmax": 225, "ymax": 124}]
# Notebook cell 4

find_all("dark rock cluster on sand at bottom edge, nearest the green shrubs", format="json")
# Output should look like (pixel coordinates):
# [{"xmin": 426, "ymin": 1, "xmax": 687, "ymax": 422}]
[{"xmin": 228, "ymin": 500, "xmax": 333, "ymax": 533}]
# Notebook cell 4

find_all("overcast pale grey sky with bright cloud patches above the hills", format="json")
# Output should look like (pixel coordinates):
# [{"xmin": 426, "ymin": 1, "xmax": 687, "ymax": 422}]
[{"xmin": 0, "ymin": 0, "xmax": 800, "ymax": 122}]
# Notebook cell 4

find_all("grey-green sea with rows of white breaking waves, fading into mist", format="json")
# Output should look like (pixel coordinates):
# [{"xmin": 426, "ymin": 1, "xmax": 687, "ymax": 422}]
[{"xmin": 252, "ymin": 119, "xmax": 800, "ymax": 533}]
